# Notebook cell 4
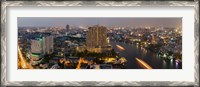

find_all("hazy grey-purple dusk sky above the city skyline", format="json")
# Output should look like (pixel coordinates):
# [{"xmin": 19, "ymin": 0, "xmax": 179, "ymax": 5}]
[{"xmin": 17, "ymin": 17, "xmax": 182, "ymax": 27}]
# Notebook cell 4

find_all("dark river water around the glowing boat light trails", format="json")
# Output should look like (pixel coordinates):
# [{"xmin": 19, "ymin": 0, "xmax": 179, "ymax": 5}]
[{"xmin": 110, "ymin": 41, "xmax": 182, "ymax": 69}]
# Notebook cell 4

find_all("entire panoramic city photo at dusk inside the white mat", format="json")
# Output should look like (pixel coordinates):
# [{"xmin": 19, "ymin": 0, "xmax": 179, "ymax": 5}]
[{"xmin": 17, "ymin": 17, "xmax": 182, "ymax": 69}]
